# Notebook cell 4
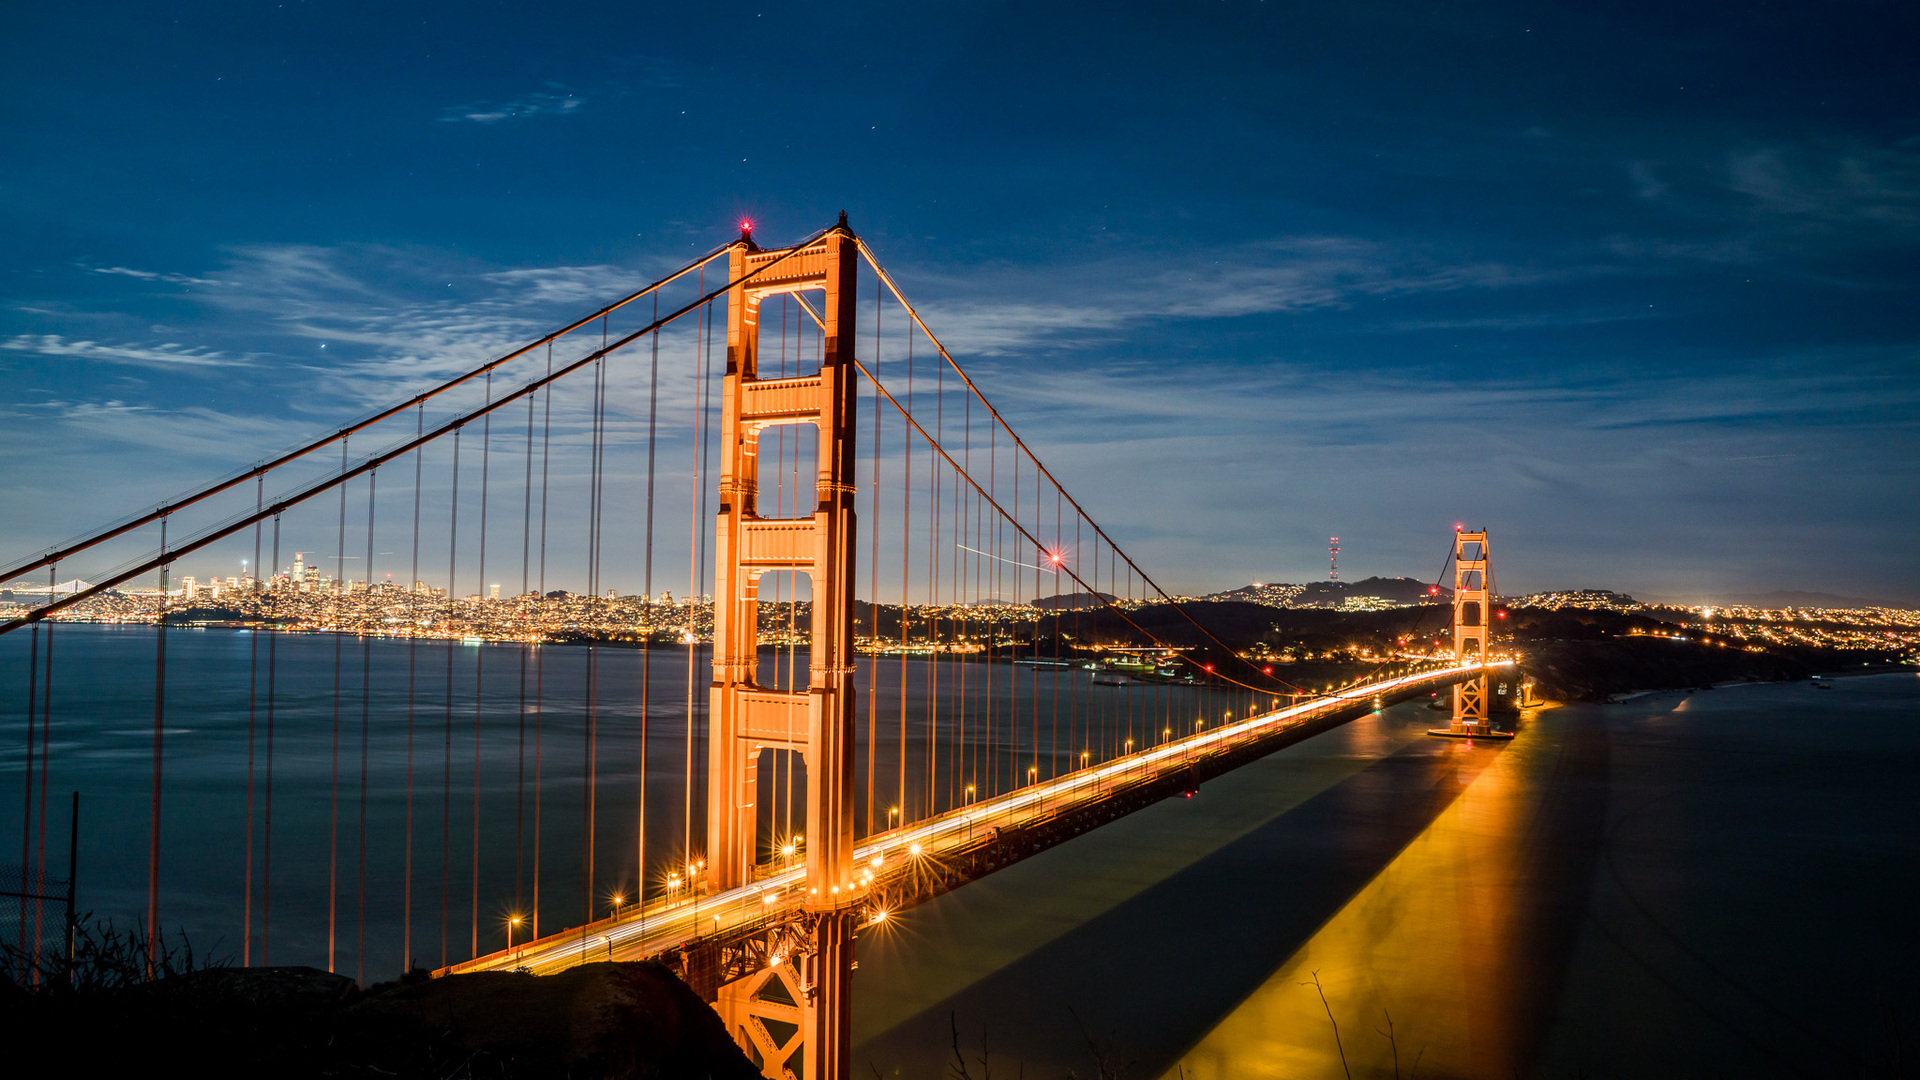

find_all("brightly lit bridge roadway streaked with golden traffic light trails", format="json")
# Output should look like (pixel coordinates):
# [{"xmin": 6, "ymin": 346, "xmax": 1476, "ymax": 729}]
[{"xmin": 434, "ymin": 661, "xmax": 1513, "ymax": 976}]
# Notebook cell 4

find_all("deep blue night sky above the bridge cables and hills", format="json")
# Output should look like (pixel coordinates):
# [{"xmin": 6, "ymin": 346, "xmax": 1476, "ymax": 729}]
[{"xmin": 0, "ymin": 0, "xmax": 1920, "ymax": 601}]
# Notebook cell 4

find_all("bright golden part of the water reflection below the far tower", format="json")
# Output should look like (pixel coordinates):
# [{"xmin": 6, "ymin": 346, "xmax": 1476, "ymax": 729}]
[{"xmin": 1165, "ymin": 732, "xmax": 1538, "ymax": 1080}]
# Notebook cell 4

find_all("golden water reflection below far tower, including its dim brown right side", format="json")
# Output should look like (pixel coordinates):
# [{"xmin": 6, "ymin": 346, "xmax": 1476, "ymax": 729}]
[{"xmin": 1165, "ymin": 707, "xmax": 1605, "ymax": 1080}]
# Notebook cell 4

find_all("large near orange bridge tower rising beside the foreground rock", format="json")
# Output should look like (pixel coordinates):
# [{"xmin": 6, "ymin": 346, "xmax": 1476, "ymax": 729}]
[{"xmin": 707, "ymin": 213, "xmax": 858, "ymax": 1080}]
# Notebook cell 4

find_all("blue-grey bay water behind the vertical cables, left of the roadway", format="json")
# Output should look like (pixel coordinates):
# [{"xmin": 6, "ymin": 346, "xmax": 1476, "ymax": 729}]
[{"xmin": 0, "ymin": 625, "xmax": 1242, "ymax": 978}]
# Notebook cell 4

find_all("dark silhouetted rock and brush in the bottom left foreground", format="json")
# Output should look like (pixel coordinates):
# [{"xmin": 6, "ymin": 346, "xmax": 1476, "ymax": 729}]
[{"xmin": 0, "ymin": 963, "xmax": 760, "ymax": 1080}]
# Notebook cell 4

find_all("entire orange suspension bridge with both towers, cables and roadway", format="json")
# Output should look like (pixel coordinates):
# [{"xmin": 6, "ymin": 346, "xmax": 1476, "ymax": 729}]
[{"xmin": 0, "ymin": 213, "xmax": 1505, "ymax": 1080}]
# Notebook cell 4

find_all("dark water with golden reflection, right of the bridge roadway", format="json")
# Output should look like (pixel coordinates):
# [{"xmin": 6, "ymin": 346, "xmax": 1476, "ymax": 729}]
[{"xmin": 854, "ymin": 675, "xmax": 1920, "ymax": 1080}]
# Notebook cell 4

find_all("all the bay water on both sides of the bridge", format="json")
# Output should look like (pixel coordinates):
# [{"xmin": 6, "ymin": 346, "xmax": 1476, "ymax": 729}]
[{"xmin": 0, "ymin": 626, "xmax": 1920, "ymax": 1080}]
